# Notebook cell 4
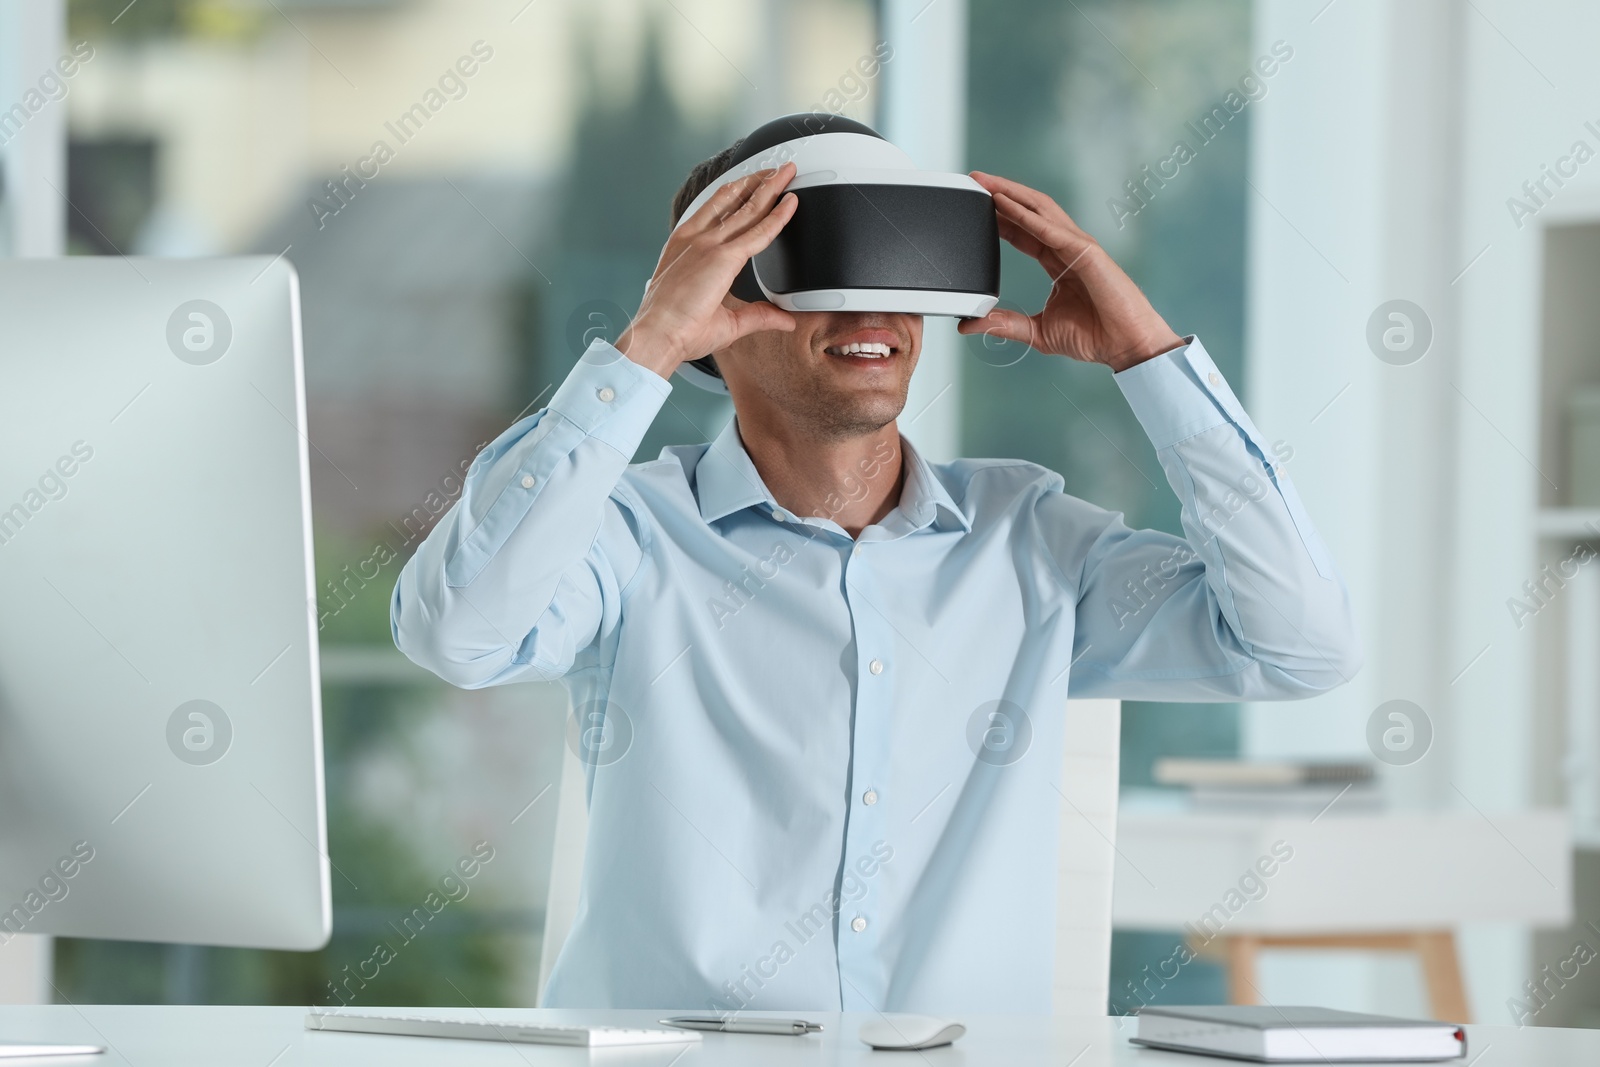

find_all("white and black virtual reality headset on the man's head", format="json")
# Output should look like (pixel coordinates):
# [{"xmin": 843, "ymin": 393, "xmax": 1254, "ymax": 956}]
[{"xmin": 677, "ymin": 112, "xmax": 1000, "ymax": 394}]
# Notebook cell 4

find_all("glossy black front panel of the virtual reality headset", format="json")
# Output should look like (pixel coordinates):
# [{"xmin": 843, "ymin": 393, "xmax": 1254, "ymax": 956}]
[{"xmin": 752, "ymin": 184, "xmax": 1000, "ymax": 299}]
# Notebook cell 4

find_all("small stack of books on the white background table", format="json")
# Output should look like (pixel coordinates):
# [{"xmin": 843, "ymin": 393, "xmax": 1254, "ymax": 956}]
[{"xmin": 1154, "ymin": 758, "xmax": 1384, "ymax": 816}]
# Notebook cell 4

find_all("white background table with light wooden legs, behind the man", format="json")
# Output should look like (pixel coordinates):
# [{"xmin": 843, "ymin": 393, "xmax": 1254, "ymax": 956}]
[{"xmin": 1112, "ymin": 803, "xmax": 1573, "ymax": 1021}]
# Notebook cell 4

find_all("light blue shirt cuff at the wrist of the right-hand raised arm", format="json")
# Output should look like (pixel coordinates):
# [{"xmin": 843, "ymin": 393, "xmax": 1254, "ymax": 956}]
[{"xmin": 1114, "ymin": 334, "xmax": 1253, "ymax": 451}]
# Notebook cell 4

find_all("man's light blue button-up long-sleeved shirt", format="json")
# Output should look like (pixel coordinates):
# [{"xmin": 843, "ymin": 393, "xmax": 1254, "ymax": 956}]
[{"xmin": 392, "ymin": 338, "xmax": 1360, "ymax": 1013}]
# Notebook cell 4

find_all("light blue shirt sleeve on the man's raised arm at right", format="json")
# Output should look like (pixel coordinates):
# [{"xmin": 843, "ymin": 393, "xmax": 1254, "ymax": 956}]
[{"xmin": 1070, "ymin": 338, "xmax": 1360, "ymax": 701}]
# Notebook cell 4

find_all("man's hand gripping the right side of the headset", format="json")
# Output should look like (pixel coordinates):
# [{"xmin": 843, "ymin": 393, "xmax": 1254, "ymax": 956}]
[{"xmin": 955, "ymin": 171, "xmax": 1184, "ymax": 371}]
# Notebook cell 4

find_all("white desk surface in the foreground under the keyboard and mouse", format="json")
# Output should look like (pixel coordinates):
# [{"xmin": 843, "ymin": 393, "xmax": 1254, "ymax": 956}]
[{"xmin": 0, "ymin": 1005, "xmax": 1600, "ymax": 1067}]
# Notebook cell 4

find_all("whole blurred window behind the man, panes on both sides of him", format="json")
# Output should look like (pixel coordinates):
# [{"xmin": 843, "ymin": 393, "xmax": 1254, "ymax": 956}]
[{"xmin": 40, "ymin": 0, "xmax": 1250, "ymax": 1005}]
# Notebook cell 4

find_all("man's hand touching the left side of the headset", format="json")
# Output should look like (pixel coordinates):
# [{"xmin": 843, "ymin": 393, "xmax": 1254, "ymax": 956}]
[{"xmin": 616, "ymin": 162, "xmax": 798, "ymax": 378}]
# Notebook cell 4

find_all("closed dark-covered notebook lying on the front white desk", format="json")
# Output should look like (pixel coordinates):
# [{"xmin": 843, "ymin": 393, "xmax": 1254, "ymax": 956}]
[{"xmin": 1131, "ymin": 1005, "xmax": 1467, "ymax": 1064}]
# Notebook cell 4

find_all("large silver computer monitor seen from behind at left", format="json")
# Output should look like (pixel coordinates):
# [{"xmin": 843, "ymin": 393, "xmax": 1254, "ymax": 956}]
[{"xmin": 0, "ymin": 258, "xmax": 331, "ymax": 952}]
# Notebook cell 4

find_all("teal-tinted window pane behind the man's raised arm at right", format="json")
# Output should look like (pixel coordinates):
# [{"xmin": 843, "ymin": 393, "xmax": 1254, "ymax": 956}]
[{"xmin": 962, "ymin": 0, "xmax": 1253, "ymax": 1013}]
